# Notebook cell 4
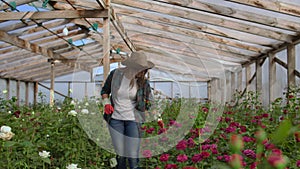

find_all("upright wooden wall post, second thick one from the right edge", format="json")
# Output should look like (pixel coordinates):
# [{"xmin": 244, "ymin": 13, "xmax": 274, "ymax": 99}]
[{"xmin": 269, "ymin": 53, "xmax": 276, "ymax": 104}]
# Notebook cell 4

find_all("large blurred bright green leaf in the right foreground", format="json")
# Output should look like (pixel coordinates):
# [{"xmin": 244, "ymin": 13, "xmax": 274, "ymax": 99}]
[{"xmin": 271, "ymin": 119, "xmax": 292, "ymax": 144}]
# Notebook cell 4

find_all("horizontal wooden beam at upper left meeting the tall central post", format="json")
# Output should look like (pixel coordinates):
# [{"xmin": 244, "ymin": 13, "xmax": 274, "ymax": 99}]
[{"xmin": 0, "ymin": 9, "xmax": 108, "ymax": 21}]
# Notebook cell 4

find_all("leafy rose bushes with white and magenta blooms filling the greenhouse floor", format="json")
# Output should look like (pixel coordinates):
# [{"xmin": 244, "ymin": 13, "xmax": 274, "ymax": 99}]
[{"xmin": 0, "ymin": 88, "xmax": 300, "ymax": 169}]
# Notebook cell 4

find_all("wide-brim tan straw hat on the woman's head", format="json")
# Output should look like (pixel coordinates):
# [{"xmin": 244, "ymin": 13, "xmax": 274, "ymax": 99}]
[{"xmin": 121, "ymin": 51, "xmax": 154, "ymax": 70}]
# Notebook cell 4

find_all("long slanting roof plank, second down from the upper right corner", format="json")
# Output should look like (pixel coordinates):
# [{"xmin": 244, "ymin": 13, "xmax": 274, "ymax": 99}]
[{"xmin": 159, "ymin": 0, "xmax": 300, "ymax": 31}]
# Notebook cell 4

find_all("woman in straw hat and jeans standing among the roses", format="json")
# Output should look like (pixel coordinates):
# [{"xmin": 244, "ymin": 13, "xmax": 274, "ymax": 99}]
[{"xmin": 101, "ymin": 51, "xmax": 154, "ymax": 169}]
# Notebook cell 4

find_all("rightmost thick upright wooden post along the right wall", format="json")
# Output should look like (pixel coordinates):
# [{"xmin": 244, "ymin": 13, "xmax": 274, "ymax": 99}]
[{"xmin": 287, "ymin": 44, "xmax": 296, "ymax": 88}]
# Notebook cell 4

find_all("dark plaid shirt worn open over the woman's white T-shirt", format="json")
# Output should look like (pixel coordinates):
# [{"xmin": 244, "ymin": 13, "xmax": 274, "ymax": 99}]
[{"xmin": 101, "ymin": 68, "xmax": 153, "ymax": 122}]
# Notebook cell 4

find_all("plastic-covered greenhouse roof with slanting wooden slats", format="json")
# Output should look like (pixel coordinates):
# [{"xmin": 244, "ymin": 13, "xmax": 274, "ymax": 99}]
[{"xmin": 0, "ymin": 0, "xmax": 300, "ymax": 81}]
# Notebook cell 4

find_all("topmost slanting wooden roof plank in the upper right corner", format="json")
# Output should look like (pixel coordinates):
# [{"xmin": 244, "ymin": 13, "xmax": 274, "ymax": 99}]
[{"xmin": 227, "ymin": 0, "xmax": 300, "ymax": 16}]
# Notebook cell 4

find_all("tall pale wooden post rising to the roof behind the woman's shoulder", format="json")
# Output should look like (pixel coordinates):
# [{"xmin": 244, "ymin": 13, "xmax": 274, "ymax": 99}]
[{"xmin": 102, "ymin": 1, "xmax": 110, "ymax": 85}]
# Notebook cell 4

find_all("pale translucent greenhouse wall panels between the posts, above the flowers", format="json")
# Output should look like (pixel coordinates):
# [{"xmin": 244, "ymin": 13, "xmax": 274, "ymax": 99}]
[{"xmin": 0, "ymin": 44, "xmax": 300, "ymax": 106}]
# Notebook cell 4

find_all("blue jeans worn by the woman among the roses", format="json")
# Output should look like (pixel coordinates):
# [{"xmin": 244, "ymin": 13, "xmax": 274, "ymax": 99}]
[{"xmin": 109, "ymin": 118, "xmax": 140, "ymax": 169}]
